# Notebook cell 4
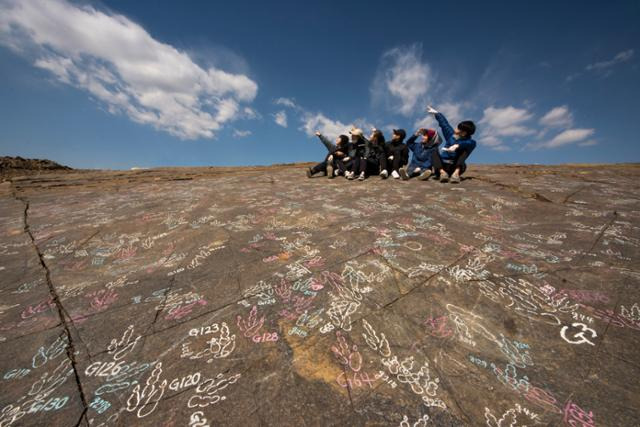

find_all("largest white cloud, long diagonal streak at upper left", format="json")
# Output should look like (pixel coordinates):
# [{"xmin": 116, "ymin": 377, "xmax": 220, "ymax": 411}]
[{"xmin": 0, "ymin": 0, "xmax": 258, "ymax": 139}]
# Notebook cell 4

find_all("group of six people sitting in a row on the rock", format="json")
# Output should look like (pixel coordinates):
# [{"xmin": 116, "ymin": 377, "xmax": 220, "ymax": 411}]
[{"xmin": 307, "ymin": 106, "xmax": 476, "ymax": 183}]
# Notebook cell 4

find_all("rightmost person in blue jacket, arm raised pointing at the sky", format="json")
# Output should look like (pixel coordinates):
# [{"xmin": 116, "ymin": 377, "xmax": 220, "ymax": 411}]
[{"xmin": 427, "ymin": 105, "xmax": 476, "ymax": 184}]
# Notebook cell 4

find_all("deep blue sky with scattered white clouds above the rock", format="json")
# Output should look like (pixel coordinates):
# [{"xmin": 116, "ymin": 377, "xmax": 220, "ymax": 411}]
[{"xmin": 0, "ymin": 0, "xmax": 640, "ymax": 168}]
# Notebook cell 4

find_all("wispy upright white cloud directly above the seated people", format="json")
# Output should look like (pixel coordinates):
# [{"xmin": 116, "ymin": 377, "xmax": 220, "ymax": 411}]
[{"xmin": 371, "ymin": 44, "xmax": 432, "ymax": 116}]
